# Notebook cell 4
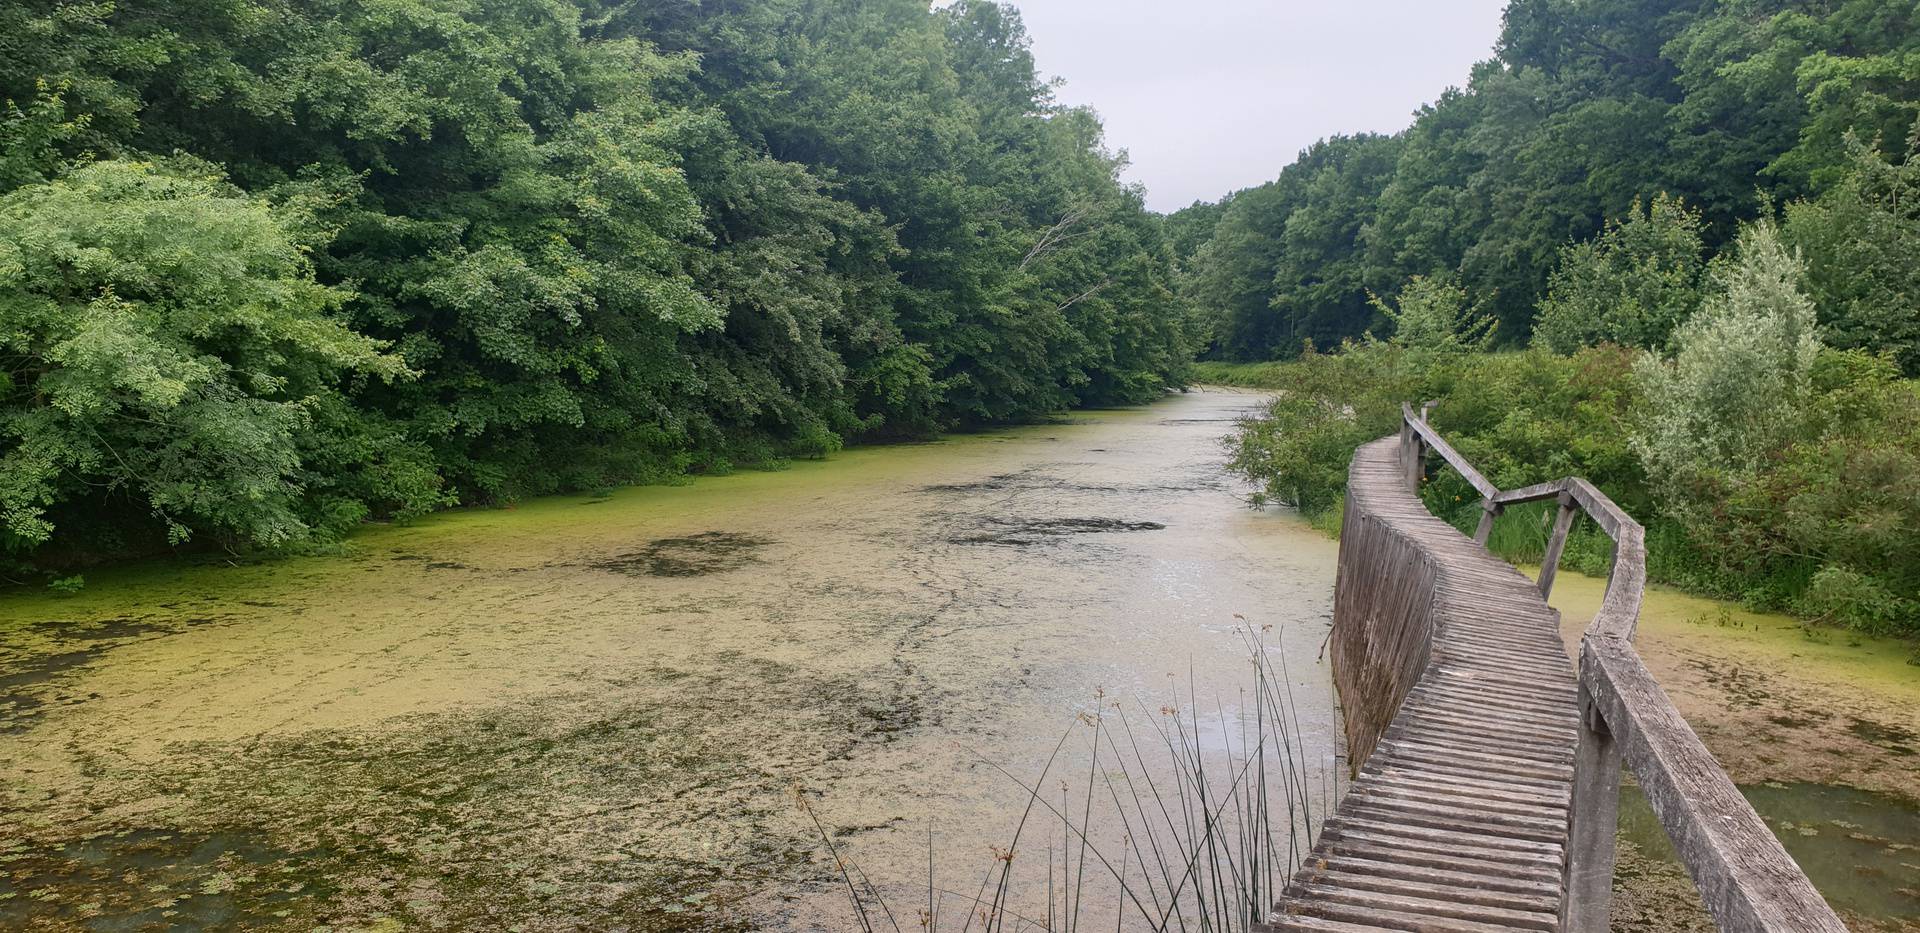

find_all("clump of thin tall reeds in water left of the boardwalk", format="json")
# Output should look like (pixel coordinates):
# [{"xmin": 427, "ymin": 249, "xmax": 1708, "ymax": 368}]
[{"xmin": 799, "ymin": 628, "xmax": 1338, "ymax": 933}]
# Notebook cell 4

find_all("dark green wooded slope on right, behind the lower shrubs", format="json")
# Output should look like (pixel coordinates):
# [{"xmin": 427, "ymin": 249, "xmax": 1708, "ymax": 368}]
[{"xmin": 1169, "ymin": 0, "xmax": 1920, "ymax": 364}]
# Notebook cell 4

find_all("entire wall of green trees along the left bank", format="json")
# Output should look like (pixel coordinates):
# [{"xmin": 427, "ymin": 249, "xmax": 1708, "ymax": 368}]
[{"xmin": 0, "ymin": 0, "xmax": 1192, "ymax": 562}]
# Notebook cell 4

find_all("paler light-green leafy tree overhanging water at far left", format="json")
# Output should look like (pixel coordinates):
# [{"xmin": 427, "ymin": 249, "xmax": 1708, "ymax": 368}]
[{"xmin": 0, "ymin": 161, "xmax": 422, "ymax": 551}]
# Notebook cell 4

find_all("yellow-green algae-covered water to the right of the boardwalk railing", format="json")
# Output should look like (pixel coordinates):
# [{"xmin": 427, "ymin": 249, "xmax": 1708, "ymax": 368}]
[{"xmin": 1553, "ymin": 570, "xmax": 1920, "ymax": 933}]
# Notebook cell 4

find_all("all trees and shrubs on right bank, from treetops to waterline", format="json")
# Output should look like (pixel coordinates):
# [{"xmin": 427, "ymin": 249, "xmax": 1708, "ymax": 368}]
[{"xmin": 1167, "ymin": 0, "xmax": 1920, "ymax": 634}]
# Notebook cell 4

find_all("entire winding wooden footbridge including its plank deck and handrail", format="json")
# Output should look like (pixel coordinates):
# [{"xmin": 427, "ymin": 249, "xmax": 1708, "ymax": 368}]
[{"xmin": 1269, "ymin": 407, "xmax": 1845, "ymax": 933}]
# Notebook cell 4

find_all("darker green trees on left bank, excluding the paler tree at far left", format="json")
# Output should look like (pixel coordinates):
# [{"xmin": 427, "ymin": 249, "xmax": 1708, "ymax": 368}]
[{"xmin": 0, "ymin": 0, "xmax": 1192, "ymax": 553}]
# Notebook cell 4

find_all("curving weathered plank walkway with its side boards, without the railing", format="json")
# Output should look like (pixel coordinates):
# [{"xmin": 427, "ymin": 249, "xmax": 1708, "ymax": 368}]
[{"xmin": 1269, "ymin": 438, "xmax": 1578, "ymax": 933}]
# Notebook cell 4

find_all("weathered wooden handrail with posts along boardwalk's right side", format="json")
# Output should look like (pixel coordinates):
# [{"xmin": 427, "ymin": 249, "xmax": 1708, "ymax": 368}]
[{"xmin": 1400, "ymin": 401, "xmax": 1847, "ymax": 933}]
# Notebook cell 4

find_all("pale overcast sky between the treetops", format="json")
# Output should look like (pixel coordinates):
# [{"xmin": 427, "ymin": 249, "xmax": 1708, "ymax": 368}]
[{"xmin": 1014, "ymin": 0, "xmax": 1505, "ymax": 211}]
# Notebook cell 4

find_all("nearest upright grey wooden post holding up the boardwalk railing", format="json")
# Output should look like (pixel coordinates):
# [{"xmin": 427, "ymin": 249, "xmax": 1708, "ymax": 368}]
[{"xmin": 1561, "ymin": 679, "xmax": 1620, "ymax": 933}]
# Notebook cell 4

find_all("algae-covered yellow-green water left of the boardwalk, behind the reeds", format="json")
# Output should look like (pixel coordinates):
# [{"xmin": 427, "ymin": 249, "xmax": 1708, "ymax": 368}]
[{"xmin": 0, "ymin": 394, "xmax": 1334, "ymax": 929}]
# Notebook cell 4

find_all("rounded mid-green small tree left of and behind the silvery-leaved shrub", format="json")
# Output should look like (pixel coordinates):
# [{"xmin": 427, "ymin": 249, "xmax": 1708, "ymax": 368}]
[{"xmin": 1534, "ymin": 196, "xmax": 1705, "ymax": 353}]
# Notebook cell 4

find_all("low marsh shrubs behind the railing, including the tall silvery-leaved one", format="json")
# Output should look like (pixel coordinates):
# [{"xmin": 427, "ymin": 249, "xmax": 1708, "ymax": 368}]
[{"xmin": 1221, "ymin": 240, "xmax": 1920, "ymax": 634}]
